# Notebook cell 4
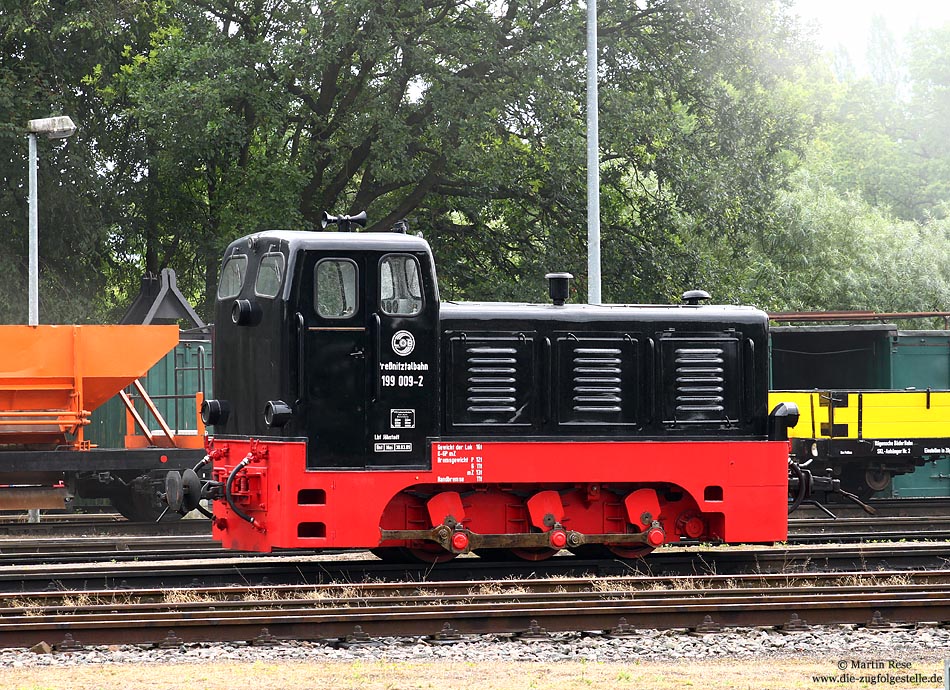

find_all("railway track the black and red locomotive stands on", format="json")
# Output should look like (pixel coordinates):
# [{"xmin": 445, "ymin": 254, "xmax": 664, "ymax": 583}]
[{"xmin": 0, "ymin": 542, "xmax": 950, "ymax": 592}]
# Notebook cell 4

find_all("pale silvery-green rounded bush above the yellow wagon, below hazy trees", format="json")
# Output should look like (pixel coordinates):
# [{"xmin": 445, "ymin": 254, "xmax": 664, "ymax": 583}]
[{"xmin": 747, "ymin": 169, "xmax": 950, "ymax": 312}]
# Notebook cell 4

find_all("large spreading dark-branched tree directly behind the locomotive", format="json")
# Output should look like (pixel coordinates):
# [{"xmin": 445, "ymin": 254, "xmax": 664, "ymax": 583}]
[{"xmin": 1, "ymin": 0, "xmax": 824, "ymax": 313}]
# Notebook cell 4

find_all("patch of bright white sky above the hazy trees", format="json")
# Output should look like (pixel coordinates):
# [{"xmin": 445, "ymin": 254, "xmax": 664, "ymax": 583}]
[{"xmin": 795, "ymin": 0, "xmax": 950, "ymax": 71}]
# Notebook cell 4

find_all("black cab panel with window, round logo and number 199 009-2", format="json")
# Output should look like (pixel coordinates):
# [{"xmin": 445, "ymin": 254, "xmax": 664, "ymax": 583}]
[{"xmin": 367, "ymin": 252, "xmax": 439, "ymax": 467}]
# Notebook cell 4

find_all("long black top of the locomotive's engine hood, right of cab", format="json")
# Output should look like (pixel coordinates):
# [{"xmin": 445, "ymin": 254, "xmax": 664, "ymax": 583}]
[{"xmin": 441, "ymin": 302, "xmax": 768, "ymax": 324}]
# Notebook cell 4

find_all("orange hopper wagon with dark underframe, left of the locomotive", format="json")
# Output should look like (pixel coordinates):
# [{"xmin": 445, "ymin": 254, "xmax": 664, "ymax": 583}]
[{"xmin": 0, "ymin": 325, "xmax": 206, "ymax": 510}]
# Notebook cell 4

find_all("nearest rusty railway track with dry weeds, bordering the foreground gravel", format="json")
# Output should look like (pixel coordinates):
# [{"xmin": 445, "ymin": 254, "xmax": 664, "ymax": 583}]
[{"xmin": 0, "ymin": 571, "xmax": 950, "ymax": 650}]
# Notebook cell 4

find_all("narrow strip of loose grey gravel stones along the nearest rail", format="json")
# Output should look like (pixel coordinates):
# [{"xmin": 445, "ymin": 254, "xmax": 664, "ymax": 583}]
[{"xmin": 0, "ymin": 626, "xmax": 950, "ymax": 668}]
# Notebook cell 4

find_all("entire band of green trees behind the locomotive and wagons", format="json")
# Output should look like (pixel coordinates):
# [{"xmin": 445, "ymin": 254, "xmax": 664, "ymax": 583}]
[{"xmin": 0, "ymin": 0, "xmax": 950, "ymax": 321}]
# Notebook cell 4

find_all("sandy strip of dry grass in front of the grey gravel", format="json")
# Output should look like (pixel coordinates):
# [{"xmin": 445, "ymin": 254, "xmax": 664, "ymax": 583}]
[{"xmin": 0, "ymin": 659, "xmax": 943, "ymax": 690}]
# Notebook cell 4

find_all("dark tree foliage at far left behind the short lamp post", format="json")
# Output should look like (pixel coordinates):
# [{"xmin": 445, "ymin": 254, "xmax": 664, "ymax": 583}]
[{"xmin": 0, "ymin": 0, "xmax": 146, "ymax": 323}]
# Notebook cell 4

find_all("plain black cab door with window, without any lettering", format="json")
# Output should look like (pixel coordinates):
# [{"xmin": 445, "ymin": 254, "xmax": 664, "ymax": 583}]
[{"xmin": 295, "ymin": 256, "xmax": 370, "ymax": 469}]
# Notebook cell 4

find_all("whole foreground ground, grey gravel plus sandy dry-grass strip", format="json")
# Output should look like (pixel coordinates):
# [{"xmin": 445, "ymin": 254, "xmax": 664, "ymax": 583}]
[{"xmin": 0, "ymin": 627, "xmax": 950, "ymax": 690}]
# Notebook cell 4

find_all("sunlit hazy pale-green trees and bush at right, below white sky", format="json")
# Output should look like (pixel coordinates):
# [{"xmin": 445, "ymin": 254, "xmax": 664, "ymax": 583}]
[{"xmin": 740, "ymin": 17, "xmax": 950, "ymax": 311}]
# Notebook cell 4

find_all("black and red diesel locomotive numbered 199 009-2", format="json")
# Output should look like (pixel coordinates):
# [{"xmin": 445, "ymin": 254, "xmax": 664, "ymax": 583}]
[{"xmin": 166, "ymin": 216, "xmax": 797, "ymax": 562}]
